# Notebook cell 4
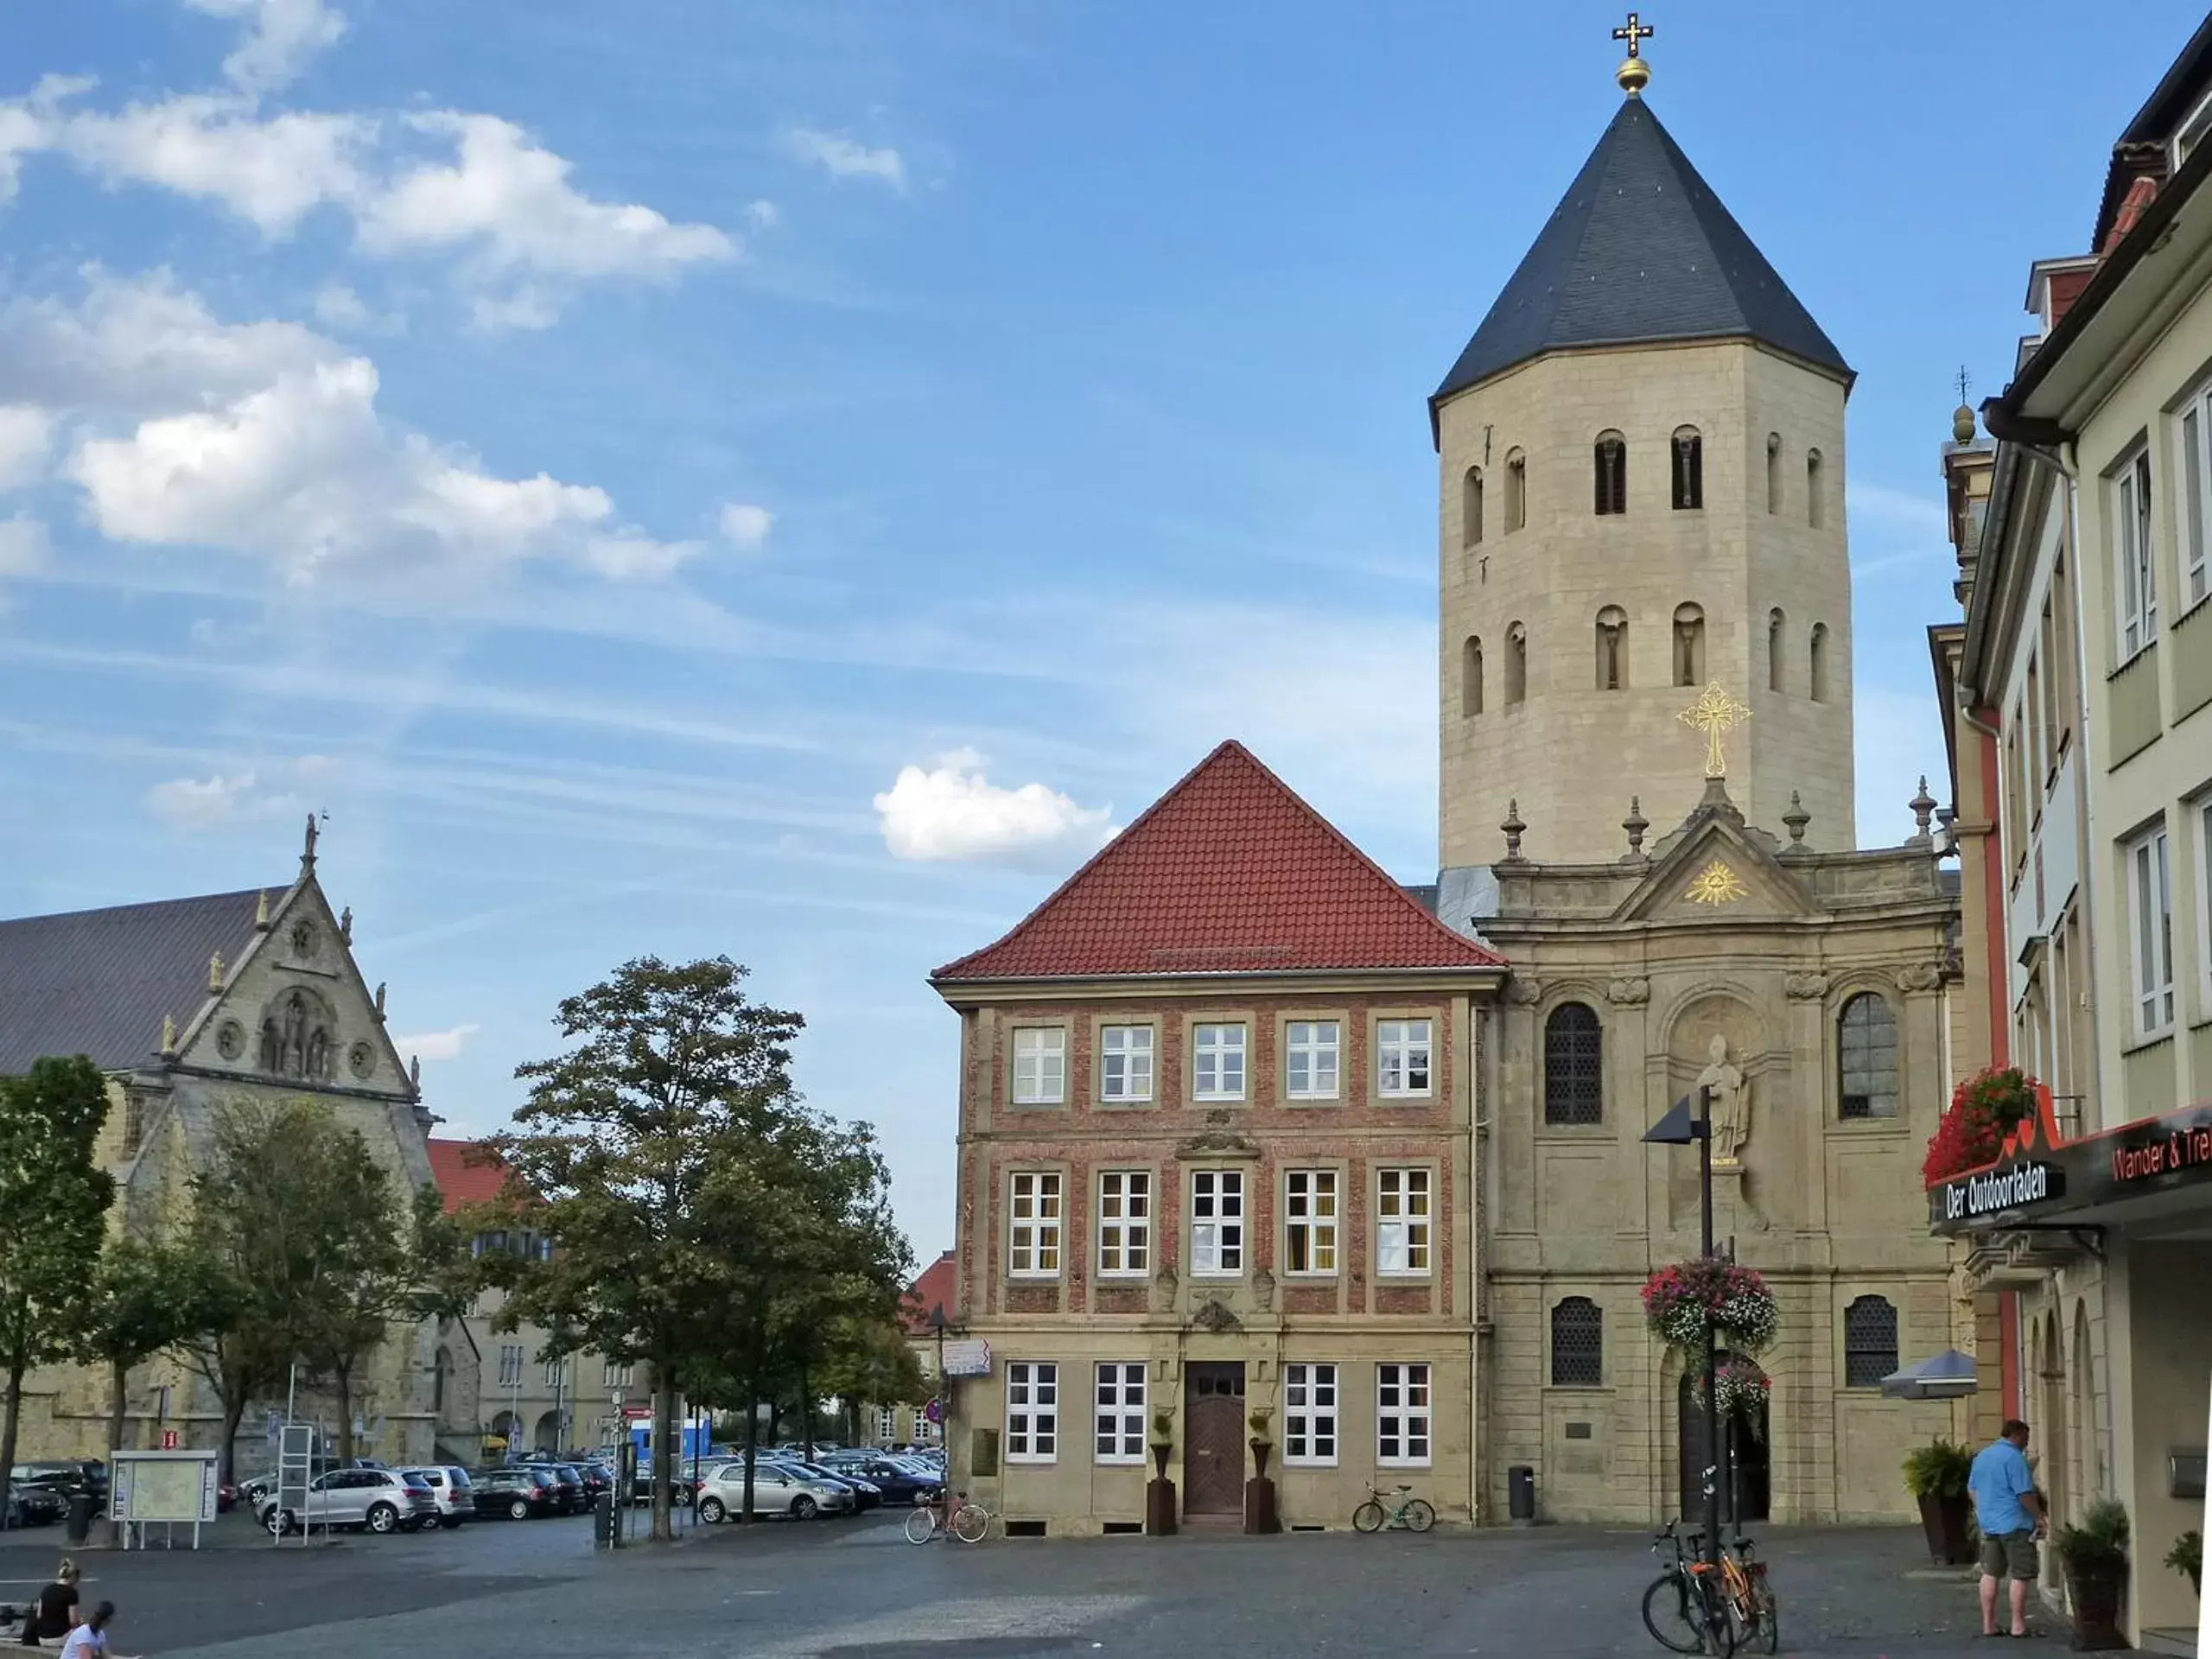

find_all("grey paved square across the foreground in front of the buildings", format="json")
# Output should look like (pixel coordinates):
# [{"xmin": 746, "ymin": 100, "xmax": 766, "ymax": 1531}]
[{"xmin": 0, "ymin": 1516, "xmax": 2106, "ymax": 1659}]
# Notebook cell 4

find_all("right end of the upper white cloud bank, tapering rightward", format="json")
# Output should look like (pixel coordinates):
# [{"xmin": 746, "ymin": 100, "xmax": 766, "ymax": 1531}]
[{"xmin": 360, "ymin": 111, "xmax": 736, "ymax": 276}]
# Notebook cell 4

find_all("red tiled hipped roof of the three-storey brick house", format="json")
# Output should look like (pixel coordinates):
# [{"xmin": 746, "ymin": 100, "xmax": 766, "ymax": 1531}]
[{"xmin": 933, "ymin": 741, "xmax": 1504, "ymax": 980}]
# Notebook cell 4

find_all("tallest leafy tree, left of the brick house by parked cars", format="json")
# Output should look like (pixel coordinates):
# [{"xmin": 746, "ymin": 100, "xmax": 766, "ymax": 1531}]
[{"xmin": 491, "ymin": 957, "xmax": 803, "ymax": 1540}]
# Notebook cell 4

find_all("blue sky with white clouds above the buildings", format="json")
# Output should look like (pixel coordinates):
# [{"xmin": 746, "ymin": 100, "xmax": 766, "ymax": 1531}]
[{"xmin": 0, "ymin": 0, "xmax": 2199, "ymax": 1256}]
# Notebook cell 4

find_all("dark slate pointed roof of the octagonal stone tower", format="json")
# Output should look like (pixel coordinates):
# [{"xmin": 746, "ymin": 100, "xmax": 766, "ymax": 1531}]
[{"xmin": 1429, "ymin": 98, "xmax": 1852, "ymax": 416}]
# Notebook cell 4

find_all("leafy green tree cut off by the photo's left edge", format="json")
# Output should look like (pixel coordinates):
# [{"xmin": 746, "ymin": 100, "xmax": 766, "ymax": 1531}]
[{"xmin": 0, "ymin": 1055, "xmax": 115, "ymax": 1504}]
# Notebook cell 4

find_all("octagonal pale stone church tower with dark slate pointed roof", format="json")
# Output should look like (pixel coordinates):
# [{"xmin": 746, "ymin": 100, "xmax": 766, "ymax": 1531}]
[{"xmin": 1429, "ymin": 60, "xmax": 1856, "ymax": 868}]
